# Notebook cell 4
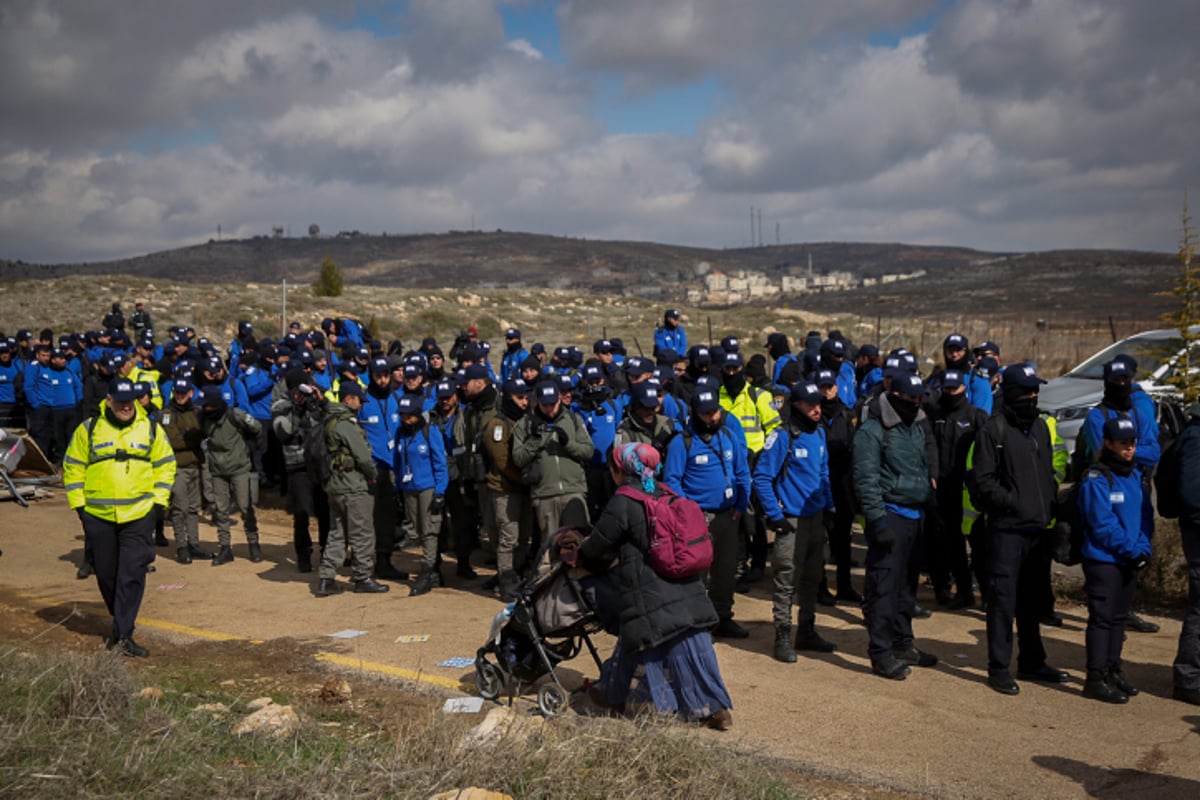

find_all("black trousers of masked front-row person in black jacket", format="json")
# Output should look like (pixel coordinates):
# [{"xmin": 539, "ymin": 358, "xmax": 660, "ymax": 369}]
[{"xmin": 984, "ymin": 530, "xmax": 1050, "ymax": 676}]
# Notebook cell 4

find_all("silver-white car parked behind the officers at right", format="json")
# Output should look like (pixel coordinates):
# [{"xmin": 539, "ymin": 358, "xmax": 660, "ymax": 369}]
[{"xmin": 1038, "ymin": 330, "xmax": 1183, "ymax": 450}]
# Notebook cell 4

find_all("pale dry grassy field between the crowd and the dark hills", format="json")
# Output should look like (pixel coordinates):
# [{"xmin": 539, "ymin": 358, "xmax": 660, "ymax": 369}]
[{"xmin": 0, "ymin": 276, "xmax": 1123, "ymax": 375}]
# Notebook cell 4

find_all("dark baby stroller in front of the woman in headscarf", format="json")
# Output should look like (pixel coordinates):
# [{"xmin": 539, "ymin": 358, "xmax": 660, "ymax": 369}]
[{"xmin": 475, "ymin": 531, "xmax": 604, "ymax": 717}]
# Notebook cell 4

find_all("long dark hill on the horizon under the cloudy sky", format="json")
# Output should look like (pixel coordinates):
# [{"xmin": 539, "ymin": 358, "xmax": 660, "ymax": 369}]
[{"xmin": 0, "ymin": 230, "xmax": 1177, "ymax": 319}]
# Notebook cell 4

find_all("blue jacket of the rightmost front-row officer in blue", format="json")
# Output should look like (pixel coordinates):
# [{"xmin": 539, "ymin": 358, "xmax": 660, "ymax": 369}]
[{"xmin": 1079, "ymin": 468, "xmax": 1150, "ymax": 564}]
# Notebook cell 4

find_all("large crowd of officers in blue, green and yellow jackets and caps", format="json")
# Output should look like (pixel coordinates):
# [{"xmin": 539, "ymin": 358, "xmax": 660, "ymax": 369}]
[{"xmin": 0, "ymin": 303, "xmax": 1195, "ymax": 702}]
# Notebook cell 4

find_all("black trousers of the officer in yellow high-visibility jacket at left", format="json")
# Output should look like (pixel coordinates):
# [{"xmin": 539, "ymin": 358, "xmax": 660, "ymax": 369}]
[{"xmin": 82, "ymin": 512, "xmax": 155, "ymax": 640}]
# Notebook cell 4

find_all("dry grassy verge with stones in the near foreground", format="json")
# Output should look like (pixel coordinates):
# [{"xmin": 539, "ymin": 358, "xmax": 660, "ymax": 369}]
[{"xmin": 0, "ymin": 651, "xmax": 820, "ymax": 800}]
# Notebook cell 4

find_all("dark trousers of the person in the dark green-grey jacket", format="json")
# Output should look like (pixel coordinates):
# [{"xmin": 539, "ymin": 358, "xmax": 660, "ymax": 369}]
[{"xmin": 863, "ymin": 511, "xmax": 922, "ymax": 661}]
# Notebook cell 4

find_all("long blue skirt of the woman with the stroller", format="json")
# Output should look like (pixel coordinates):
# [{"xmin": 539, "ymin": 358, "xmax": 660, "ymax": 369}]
[{"xmin": 600, "ymin": 630, "xmax": 733, "ymax": 720}]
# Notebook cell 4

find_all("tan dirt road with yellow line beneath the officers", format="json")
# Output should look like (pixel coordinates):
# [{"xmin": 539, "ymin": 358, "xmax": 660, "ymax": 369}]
[{"xmin": 0, "ymin": 494, "xmax": 1200, "ymax": 799}]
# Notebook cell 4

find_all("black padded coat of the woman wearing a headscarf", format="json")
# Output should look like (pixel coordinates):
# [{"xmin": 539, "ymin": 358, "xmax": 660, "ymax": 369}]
[{"xmin": 580, "ymin": 484, "xmax": 718, "ymax": 652}]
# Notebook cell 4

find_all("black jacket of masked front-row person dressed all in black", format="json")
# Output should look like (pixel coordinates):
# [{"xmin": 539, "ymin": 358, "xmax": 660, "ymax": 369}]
[{"xmin": 966, "ymin": 411, "xmax": 1058, "ymax": 530}]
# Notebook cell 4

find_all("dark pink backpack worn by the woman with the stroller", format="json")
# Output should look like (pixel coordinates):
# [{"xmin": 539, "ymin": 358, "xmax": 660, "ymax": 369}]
[{"xmin": 617, "ymin": 486, "xmax": 713, "ymax": 581}]
